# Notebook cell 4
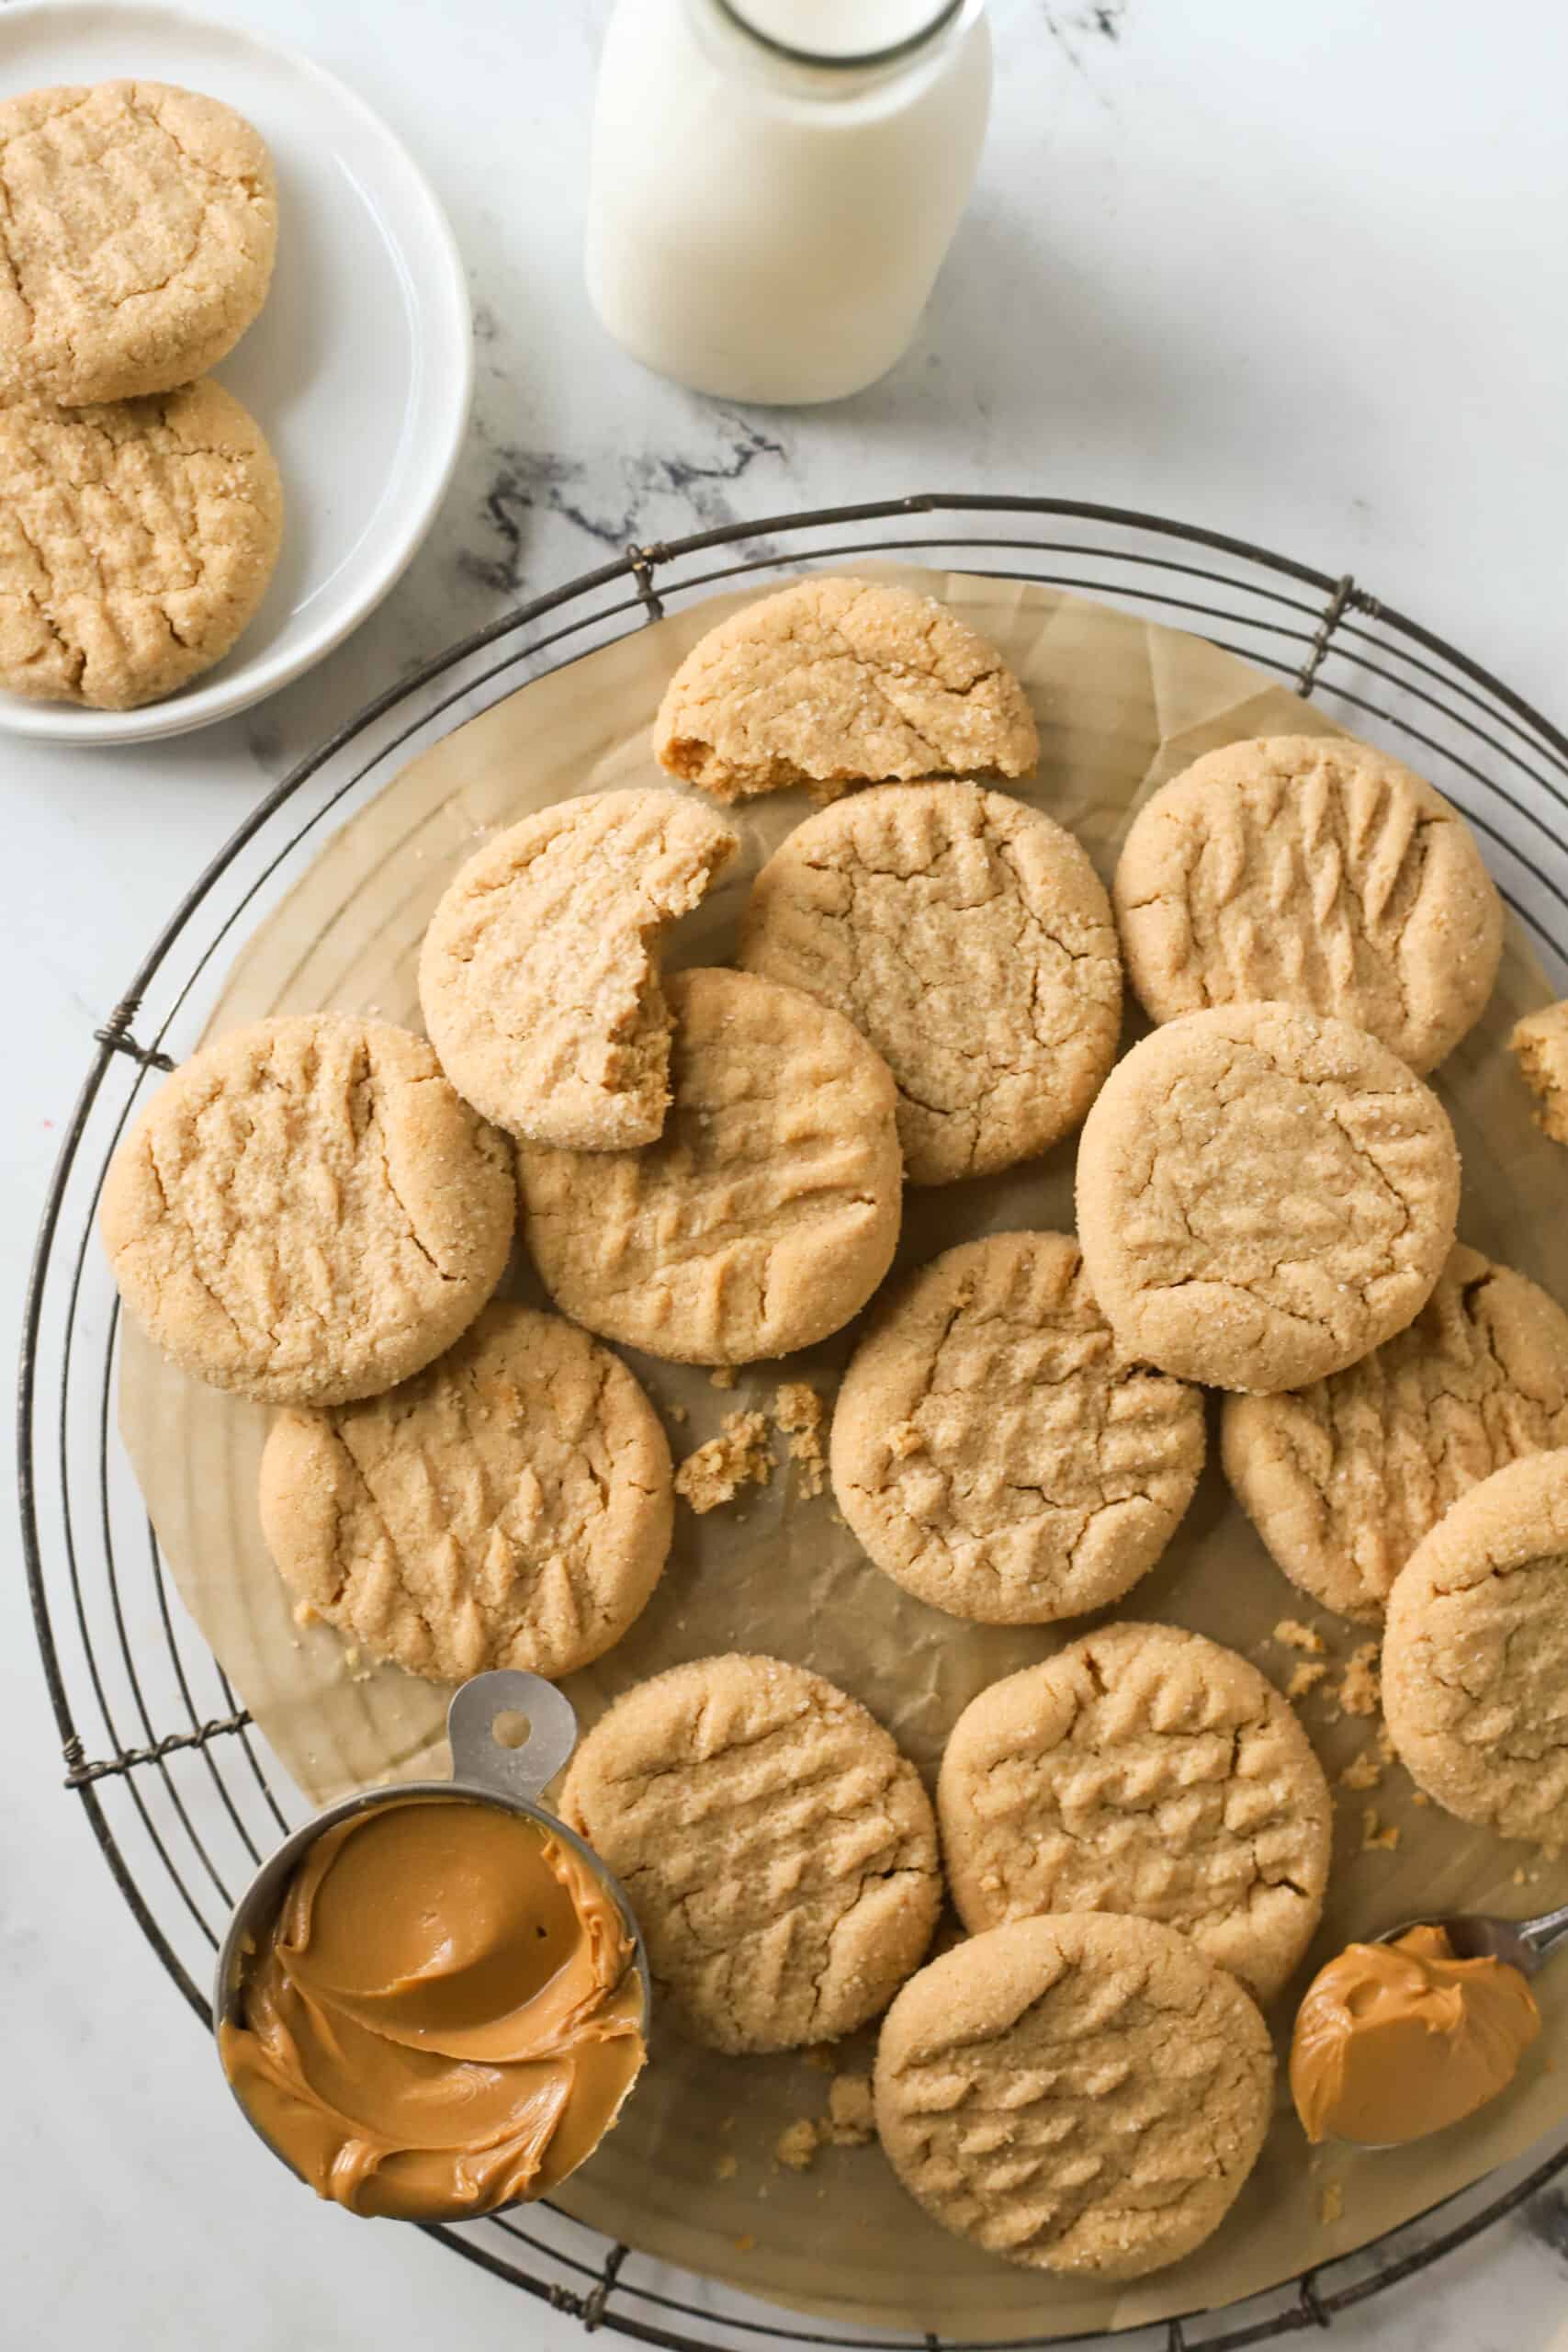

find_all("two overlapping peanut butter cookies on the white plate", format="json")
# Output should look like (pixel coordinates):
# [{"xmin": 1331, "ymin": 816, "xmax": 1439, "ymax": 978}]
[{"xmin": 0, "ymin": 83, "xmax": 282, "ymax": 710}]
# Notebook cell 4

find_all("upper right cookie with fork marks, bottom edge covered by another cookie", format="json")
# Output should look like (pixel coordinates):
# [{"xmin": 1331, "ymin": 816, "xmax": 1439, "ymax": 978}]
[{"xmin": 1117, "ymin": 736, "xmax": 1502, "ymax": 1070}]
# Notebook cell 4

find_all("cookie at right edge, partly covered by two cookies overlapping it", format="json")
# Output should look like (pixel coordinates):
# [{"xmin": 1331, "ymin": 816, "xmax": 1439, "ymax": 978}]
[{"xmin": 1220, "ymin": 1242, "xmax": 1568, "ymax": 1625}]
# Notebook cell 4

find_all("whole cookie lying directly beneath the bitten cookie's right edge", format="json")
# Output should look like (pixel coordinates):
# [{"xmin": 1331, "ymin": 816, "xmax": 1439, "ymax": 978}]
[{"xmin": 517, "ymin": 971, "xmax": 903, "ymax": 1364}]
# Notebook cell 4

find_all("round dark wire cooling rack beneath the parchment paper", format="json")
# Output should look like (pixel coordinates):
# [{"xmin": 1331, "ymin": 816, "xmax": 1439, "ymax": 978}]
[{"xmin": 18, "ymin": 496, "xmax": 1568, "ymax": 2352}]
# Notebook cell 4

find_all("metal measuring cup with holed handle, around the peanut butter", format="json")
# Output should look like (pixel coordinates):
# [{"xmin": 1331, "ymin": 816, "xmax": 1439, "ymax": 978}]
[{"xmin": 211, "ymin": 1670, "xmax": 653, "ymax": 2211}]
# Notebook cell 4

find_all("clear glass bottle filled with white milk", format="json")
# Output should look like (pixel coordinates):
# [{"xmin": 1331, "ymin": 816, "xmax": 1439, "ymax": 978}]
[{"xmin": 588, "ymin": 0, "xmax": 989, "ymax": 402}]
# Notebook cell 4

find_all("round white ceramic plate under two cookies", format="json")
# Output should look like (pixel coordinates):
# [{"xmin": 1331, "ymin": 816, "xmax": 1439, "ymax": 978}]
[{"xmin": 0, "ymin": 0, "xmax": 472, "ymax": 743}]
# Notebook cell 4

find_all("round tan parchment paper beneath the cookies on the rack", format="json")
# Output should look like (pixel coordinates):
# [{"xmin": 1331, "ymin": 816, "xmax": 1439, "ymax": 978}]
[{"xmin": 120, "ymin": 567, "xmax": 1568, "ymax": 2338}]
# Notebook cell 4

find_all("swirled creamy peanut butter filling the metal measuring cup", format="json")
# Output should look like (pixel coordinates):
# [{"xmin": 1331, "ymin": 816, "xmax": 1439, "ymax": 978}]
[{"xmin": 219, "ymin": 1797, "xmax": 644, "ymax": 2221}]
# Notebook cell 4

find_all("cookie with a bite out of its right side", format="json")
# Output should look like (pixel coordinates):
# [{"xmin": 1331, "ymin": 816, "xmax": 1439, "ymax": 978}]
[{"xmin": 419, "ymin": 793, "xmax": 736, "ymax": 1152}]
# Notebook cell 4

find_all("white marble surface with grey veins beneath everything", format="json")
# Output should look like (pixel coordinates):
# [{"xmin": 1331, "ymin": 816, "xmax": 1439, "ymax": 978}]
[{"xmin": 0, "ymin": 0, "xmax": 1568, "ymax": 2352}]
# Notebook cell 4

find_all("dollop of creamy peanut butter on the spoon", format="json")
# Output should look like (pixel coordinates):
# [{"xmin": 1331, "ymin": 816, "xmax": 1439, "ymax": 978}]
[{"xmin": 1291, "ymin": 1927, "xmax": 1540, "ymax": 2145}]
